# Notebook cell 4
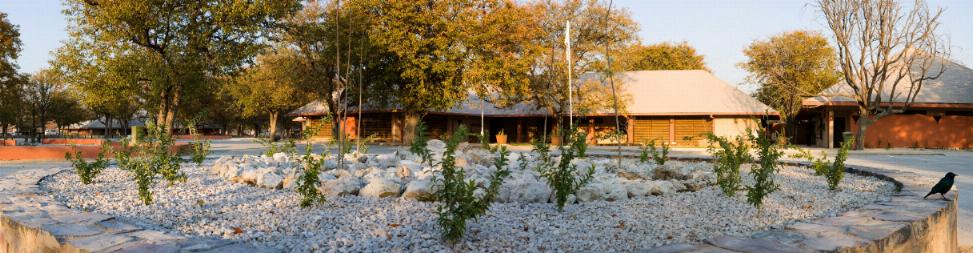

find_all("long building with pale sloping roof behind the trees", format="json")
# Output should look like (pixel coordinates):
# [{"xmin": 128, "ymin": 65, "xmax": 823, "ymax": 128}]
[{"xmin": 287, "ymin": 70, "xmax": 777, "ymax": 146}]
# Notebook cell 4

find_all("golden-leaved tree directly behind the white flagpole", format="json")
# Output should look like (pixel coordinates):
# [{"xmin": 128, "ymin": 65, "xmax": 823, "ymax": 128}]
[{"xmin": 525, "ymin": 0, "xmax": 638, "ymax": 140}]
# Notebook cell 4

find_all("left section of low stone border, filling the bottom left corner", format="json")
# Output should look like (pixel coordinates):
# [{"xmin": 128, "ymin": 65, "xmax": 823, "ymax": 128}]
[{"xmin": 0, "ymin": 169, "xmax": 279, "ymax": 252}]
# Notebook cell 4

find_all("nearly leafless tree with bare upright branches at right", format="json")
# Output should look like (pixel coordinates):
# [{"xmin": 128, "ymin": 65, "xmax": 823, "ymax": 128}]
[{"xmin": 817, "ymin": 0, "xmax": 949, "ymax": 149}]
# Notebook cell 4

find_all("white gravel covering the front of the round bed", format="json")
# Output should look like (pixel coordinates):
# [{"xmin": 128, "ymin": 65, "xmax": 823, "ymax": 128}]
[{"xmin": 41, "ymin": 155, "xmax": 893, "ymax": 252}]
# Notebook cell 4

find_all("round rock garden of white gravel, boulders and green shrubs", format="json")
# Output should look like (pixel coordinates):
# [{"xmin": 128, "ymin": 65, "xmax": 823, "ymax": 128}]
[{"xmin": 41, "ymin": 125, "xmax": 894, "ymax": 252}]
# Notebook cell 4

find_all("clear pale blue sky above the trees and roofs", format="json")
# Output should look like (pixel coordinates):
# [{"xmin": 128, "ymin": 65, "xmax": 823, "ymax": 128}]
[{"xmin": 0, "ymin": 0, "xmax": 973, "ymax": 91}]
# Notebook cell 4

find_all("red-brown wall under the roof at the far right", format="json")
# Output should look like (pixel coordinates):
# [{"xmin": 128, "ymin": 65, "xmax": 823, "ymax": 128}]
[{"xmin": 852, "ymin": 114, "xmax": 973, "ymax": 148}]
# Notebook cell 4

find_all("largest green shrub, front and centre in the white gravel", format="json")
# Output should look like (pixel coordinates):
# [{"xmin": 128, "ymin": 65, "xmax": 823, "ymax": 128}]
[{"xmin": 436, "ymin": 126, "xmax": 510, "ymax": 243}]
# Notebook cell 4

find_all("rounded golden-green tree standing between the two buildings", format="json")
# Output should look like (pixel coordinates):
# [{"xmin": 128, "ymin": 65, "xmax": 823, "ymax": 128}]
[{"xmin": 739, "ymin": 31, "xmax": 839, "ymax": 141}]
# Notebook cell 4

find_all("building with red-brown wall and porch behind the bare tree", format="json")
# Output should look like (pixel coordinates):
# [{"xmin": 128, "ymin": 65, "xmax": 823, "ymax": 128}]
[{"xmin": 792, "ymin": 58, "xmax": 973, "ymax": 148}]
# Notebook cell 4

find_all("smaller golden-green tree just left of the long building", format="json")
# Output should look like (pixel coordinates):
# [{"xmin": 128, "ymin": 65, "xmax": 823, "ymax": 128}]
[{"xmin": 225, "ymin": 48, "xmax": 308, "ymax": 139}]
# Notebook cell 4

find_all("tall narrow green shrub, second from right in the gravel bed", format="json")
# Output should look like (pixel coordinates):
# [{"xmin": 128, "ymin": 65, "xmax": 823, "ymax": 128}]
[{"xmin": 747, "ymin": 131, "xmax": 784, "ymax": 209}]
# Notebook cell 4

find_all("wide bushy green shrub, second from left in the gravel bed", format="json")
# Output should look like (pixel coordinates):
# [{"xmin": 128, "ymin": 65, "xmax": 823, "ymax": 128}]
[{"xmin": 115, "ymin": 121, "xmax": 186, "ymax": 205}]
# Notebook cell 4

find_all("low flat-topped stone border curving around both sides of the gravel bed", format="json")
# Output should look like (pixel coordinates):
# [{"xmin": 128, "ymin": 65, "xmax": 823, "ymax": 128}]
[{"xmin": 0, "ymin": 157, "xmax": 959, "ymax": 252}]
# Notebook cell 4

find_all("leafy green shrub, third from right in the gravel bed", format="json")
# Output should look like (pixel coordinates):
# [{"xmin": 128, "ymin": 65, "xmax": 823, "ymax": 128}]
[{"xmin": 707, "ymin": 134, "xmax": 753, "ymax": 197}]
